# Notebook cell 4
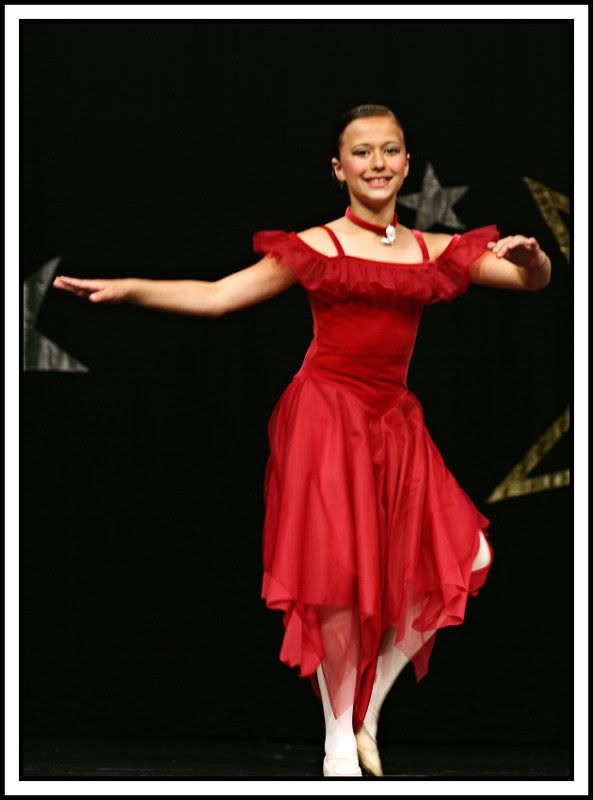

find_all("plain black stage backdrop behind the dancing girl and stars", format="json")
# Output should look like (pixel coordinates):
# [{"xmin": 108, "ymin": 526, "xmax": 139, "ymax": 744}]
[{"xmin": 21, "ymin": 20, "xmax": 573, "ymax": 744}]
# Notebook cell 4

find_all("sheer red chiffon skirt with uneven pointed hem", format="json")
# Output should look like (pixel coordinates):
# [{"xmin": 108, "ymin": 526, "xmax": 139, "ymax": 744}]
[{"xmin": 262, "ymin": 375, "xmax": 493, "ymax": 730}]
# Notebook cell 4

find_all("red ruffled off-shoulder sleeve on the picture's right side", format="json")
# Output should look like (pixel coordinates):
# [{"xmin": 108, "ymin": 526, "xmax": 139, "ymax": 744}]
[{"xmin": 430, "ymin": 225, "xmax": 500, "ymax": 303}]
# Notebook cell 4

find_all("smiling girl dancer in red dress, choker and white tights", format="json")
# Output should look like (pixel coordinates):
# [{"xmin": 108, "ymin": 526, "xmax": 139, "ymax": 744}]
[{"xmin": 53, "ymin": 105, "xmax": 551, "ymax": 776}]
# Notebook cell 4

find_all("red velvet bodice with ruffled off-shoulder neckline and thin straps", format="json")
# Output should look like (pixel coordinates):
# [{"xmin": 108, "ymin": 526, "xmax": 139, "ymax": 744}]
[{"xmin": 253, "ymin": 225, "xmax": 499, "ymax": 408}]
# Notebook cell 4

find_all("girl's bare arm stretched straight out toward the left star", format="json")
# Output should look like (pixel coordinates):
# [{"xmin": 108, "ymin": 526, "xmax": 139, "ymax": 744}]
[{"xmin": 53, "ymin": 256, "xmax": 296, "ymax": 317}]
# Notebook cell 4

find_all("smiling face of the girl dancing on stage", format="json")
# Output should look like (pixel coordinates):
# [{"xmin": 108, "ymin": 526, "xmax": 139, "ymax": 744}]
[{"xmin": 332, "ymin": 117, "xmax": 410, "ymax": 205}]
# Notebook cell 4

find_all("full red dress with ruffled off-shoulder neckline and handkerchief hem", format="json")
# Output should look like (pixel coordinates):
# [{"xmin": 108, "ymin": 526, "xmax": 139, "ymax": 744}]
[{"xmin": 253, "ymin": 225, "xmax": 500, "ymax": 730}]
